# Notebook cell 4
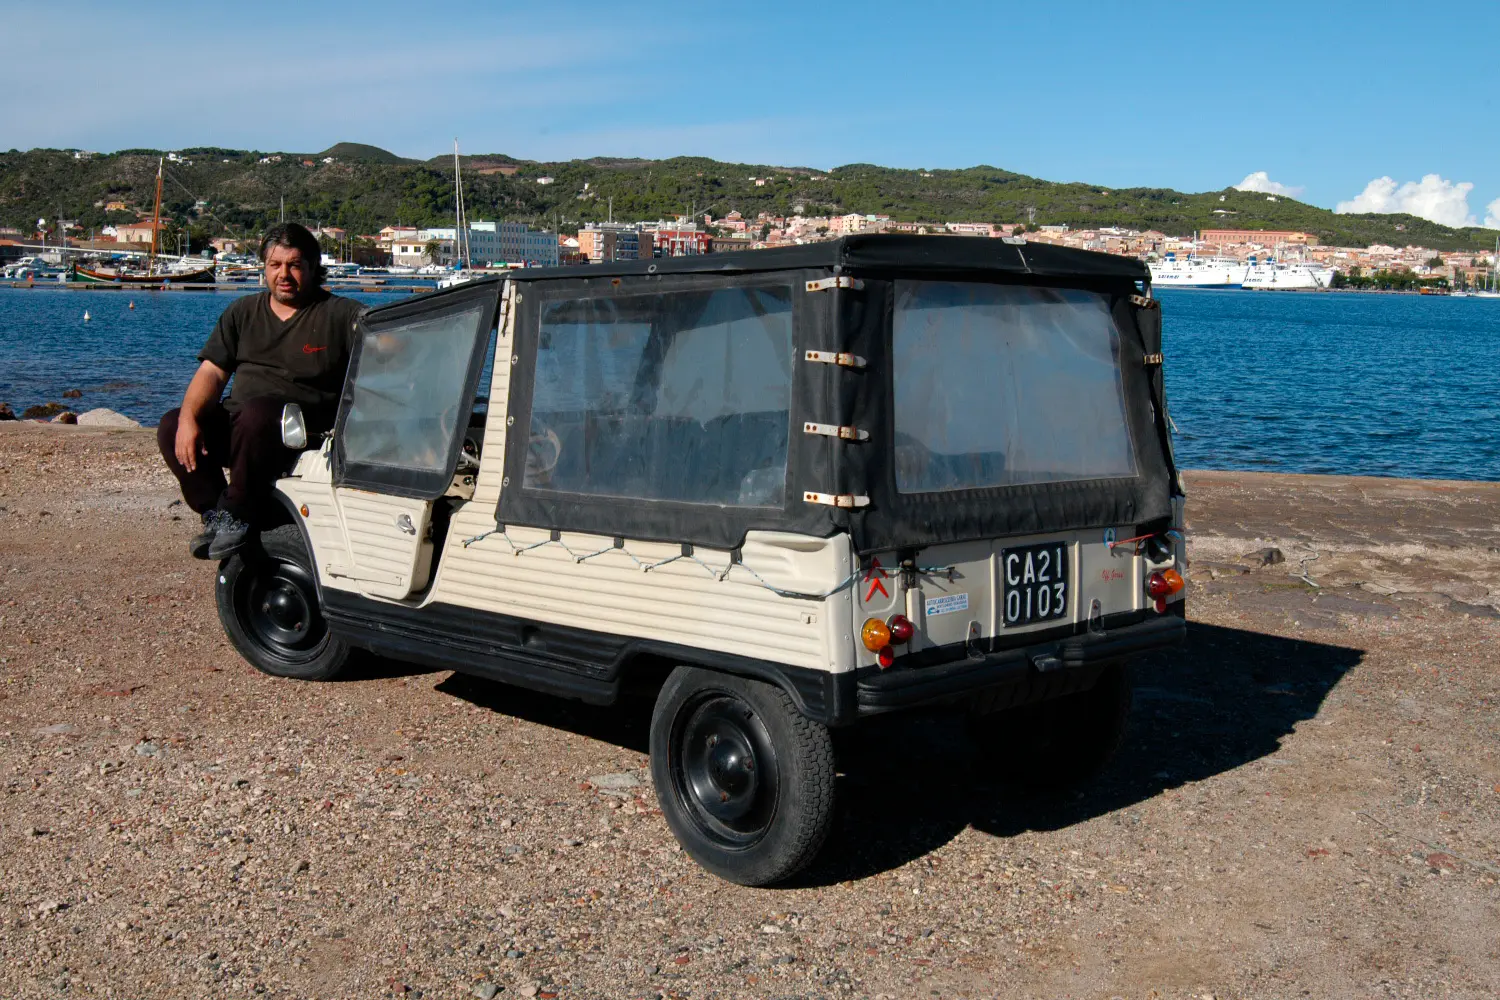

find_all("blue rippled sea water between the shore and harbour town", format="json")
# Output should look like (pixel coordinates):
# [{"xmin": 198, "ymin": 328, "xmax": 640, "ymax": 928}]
[{"xmin": 0, "ymin": 288, "xmax": 1500, "ymax": 480}]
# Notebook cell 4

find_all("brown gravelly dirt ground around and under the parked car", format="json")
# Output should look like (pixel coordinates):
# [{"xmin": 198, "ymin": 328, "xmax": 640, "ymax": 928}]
[{"xmin": 0, "ymin": 423, "xmax": 1500, "ymax": 1000}]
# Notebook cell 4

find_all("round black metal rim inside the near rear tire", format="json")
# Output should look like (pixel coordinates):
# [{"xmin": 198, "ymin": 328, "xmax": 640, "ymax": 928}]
[{"xmin": 672, "ymin": 693, "xmax": 779, "ymax": 849}]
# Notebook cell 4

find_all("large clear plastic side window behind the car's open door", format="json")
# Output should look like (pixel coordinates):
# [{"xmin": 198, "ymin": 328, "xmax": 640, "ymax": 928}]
[{"xmin": 525, "ymin": 285, "xmax": 792, "ymax": 507}]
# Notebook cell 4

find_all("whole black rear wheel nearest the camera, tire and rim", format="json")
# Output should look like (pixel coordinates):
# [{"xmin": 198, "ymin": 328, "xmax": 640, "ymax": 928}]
[{"xmin": 651, "ymin": 667, "xmax": 834, "ymax": 886}]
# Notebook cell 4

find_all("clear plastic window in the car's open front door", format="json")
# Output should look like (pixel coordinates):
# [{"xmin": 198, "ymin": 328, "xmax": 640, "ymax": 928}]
[{"xmin": 344, "ymin": 301, "xmax": 488, "ymax": 472}]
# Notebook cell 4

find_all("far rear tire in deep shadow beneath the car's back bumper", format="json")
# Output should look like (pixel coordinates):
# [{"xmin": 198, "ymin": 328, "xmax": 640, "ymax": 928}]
[{"xmin": 969, "ymin": 664, "xmax": 1131, "ymax": 792}]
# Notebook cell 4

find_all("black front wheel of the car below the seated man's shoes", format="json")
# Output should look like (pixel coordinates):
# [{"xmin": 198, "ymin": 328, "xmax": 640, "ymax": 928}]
[{"xmin": 215, "ymin": 525, "xmax": 350, "ymax": 681}]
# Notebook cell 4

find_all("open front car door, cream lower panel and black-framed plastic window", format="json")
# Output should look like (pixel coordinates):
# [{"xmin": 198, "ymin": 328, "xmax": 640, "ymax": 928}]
[{"xmin": 333, "ymin": 279, "xmax": 503, "ymax": 600}]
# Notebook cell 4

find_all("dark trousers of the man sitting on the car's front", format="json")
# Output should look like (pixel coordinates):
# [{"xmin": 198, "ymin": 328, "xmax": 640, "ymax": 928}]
[{"xmin": 156, "ymin": 397, "xmax": 319, "ymax": 525}]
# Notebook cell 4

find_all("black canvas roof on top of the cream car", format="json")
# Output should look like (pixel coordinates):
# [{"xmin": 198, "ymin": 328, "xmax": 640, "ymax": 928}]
[{"xmin": 509, "ymin": 234, "xmax": 1151, "ymax": 282}]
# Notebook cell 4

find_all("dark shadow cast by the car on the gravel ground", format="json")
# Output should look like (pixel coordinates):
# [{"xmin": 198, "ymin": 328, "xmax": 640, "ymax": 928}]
[{"xmin": 420, "ymin": 622, "xmax": 1364, "ymax": 886}]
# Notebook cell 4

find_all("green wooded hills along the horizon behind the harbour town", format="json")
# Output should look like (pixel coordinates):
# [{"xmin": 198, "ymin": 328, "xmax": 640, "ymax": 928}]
[{"xmin": 0, "ymin": 142, "xmax": 1494, "ymax": 250}]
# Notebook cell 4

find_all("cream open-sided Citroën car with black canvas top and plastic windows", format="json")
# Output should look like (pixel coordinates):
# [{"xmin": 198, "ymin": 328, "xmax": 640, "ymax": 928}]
[{"xmin": 218, "ymin": 235, "xmax": 1185, "ymax": 885}]
